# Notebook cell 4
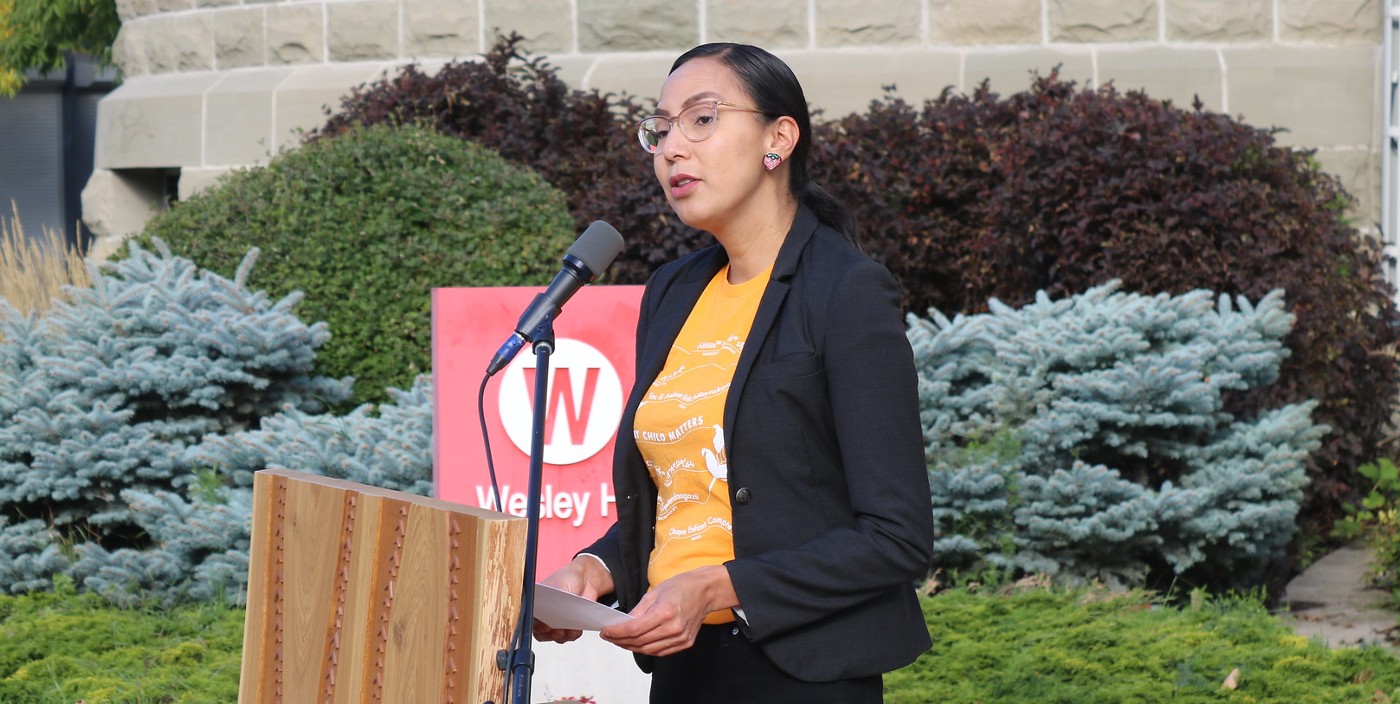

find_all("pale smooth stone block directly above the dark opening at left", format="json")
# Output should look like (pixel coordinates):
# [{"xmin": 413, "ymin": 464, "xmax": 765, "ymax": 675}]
[{"xmin": 94, "ymin": 71, "xmax": 220, "ymax": 169}]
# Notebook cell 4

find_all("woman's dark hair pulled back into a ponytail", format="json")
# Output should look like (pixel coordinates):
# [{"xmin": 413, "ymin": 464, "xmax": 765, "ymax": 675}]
[{"xmin": 671, "ymin": 42, "xmax": 860, "ymax": 242}]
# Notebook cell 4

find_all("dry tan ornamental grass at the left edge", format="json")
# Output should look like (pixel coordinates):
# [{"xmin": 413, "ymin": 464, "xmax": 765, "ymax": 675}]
[{"xmin": 0, "ymin": 203, "xmax": 91, "ymax": 314}]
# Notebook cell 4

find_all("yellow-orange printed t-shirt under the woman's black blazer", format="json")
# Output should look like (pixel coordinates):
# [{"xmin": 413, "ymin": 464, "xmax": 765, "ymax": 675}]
[{"xmin": 633, "ymin": 266, "xmax": 769, "ymax": 623}]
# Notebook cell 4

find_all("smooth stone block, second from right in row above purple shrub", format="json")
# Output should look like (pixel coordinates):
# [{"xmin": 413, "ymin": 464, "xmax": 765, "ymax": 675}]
[{"xmin": 1098, "ymin": 46, "xmax": 1225, "ymax": 112}]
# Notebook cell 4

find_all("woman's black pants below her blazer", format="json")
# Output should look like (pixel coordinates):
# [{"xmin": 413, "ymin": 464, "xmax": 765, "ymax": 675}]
[{"xmin": 651, "ymin": 624, "xmax": 885, "ymax": 704}]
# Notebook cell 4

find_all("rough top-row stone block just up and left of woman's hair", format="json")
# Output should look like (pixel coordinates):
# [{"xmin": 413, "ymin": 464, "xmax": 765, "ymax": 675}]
[{"xmin": 577, "ymin": 0, "xmax": 700, "ymax": 55}]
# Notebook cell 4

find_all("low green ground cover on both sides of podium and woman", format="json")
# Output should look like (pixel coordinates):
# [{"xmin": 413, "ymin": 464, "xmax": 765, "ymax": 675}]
[{"xmin": 0, "ymin": 584, "xmax": 1400, "ymax": 704}]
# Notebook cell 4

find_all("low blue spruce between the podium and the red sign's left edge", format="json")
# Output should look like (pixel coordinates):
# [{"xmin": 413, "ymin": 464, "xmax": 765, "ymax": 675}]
[{"xmin": 87, "ymin": 375, "xmax": 433, "ymax": 605}]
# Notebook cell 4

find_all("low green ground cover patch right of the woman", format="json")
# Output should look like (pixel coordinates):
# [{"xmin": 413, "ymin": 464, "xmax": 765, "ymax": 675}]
[{"xmin": 885, "ymin": 588, "xmax": 1400, "ymax": 704}]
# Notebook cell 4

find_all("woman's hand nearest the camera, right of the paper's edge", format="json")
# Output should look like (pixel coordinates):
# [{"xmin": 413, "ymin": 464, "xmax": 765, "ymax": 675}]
[{"xmin": 601, "ymin": 565, "xmax": 739, "ymax": 656}]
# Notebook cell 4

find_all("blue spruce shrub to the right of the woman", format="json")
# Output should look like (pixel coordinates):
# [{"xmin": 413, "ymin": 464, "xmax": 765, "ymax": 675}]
[{"xmin": 909, "ymin": 283, "xmax": 1327, "ymax": 585}]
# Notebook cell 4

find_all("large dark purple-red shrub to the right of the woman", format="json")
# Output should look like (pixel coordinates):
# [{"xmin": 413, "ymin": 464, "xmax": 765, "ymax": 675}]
[{"xmin": 813, "ymin": 74, "xmax": 1400, "ymax": 525}]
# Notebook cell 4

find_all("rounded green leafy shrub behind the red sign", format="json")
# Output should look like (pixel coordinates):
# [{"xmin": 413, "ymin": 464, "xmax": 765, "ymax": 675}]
[{"xmin": 140, "ymin": 125, "xmax": 573, "ymax": 400}]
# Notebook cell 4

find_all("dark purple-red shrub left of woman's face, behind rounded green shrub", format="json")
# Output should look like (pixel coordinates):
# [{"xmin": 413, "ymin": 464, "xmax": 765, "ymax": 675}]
[{"xmin": 308, "ymin": 32, "xmax": 700, "ymax": 286}]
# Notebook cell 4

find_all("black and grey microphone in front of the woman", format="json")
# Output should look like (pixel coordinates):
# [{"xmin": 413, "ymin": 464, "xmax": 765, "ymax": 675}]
[{"xmin": 486, "ymin": 220, "xmax": 623, "ymax": 376}]
